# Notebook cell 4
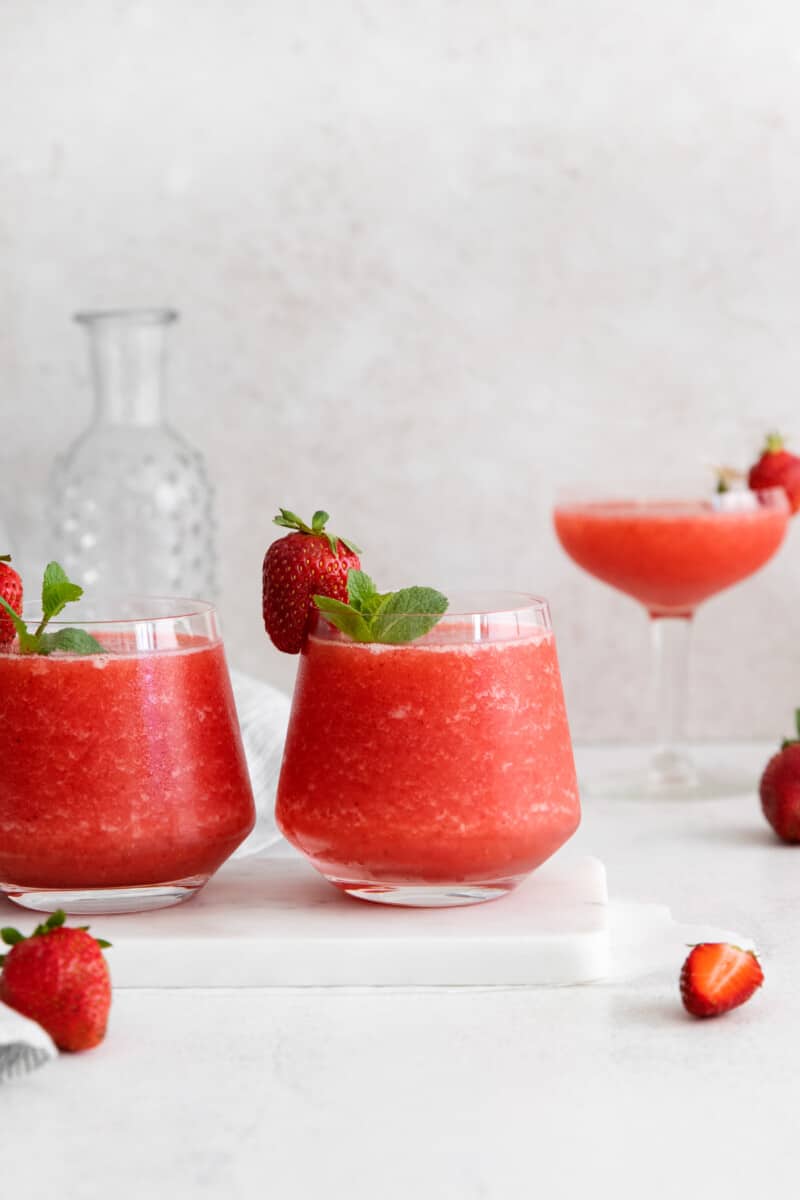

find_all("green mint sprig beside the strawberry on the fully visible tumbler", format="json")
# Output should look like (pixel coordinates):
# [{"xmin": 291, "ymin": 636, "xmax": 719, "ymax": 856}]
[{"xmin": 313, "ymin": 570, "xmax": 447, "ymax": 646}]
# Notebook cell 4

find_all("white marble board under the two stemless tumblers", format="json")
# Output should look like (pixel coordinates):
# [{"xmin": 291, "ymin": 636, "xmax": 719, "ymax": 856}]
[{"xmin": 4, "ymin": 857, "xmax": 609, "ymax": 988}]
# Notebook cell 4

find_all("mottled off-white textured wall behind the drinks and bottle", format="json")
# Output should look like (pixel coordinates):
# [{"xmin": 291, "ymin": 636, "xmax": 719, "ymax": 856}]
[{"xmin": 0, "ymin": 0, "xmax": 800, "ymax": 738}]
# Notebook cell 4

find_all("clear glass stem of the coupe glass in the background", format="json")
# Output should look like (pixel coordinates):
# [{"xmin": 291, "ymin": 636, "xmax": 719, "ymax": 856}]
[{"xmin": 650, "ymin": 616, "xmax": 697, "ymax": 791}]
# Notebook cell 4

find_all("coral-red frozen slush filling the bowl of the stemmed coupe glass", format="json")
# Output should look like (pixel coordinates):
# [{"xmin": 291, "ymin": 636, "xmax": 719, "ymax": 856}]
[{"xmin": 554, "ymin": 500, "xmax": 789, "ymax": 616}]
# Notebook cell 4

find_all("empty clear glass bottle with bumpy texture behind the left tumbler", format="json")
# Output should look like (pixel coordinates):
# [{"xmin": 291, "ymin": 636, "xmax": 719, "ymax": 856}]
[{"xmin": 50, "ymin": 308, "xmax": 216, "ymax": 599}]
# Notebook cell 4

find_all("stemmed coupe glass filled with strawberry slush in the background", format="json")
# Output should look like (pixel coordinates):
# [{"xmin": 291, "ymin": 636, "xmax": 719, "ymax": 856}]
[{"xmin": 554, "ymin": 487, "xmax": 790, "ymax": 797}]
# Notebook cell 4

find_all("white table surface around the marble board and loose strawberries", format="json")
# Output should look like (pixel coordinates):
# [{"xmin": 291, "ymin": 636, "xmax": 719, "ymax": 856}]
[{"xmin": 0, "ymin": 746, "xmax": 800, "ymax": 1200}]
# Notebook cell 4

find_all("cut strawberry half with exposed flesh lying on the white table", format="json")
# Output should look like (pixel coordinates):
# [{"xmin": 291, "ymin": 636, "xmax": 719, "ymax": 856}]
[{"xmin": 680, "ymin": 942, "xmax": 764, "ymax": 1016}]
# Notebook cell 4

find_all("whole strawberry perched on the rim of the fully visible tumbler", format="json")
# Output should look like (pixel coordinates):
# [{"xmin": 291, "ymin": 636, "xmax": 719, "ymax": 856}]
[{"xmin": 263, "ymin": 509, "xmax": 361, "ymax": 654}]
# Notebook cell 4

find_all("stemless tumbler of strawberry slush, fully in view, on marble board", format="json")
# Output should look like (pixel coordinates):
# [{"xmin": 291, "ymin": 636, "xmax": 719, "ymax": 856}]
[{"xmin": 276, "ymin": 593, "xmax": 581, "ymax": 907}]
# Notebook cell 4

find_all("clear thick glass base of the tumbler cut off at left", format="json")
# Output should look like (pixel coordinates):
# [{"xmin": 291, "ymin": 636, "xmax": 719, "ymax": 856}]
[{"xmin": 0, "ymin": 875, "xmax": 209, "ymax": 917}]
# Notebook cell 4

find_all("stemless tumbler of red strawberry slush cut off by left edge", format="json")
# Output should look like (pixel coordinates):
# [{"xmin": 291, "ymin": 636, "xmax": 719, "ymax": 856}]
[{"xmin": 0, "ymin": 598, "xmax": 254, "ymax": 913}]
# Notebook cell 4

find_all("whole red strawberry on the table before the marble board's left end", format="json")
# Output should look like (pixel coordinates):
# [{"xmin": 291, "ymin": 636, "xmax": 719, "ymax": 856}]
[{"xmin": 0, "ymin": 911, "xmax": 112, "ymax": 1050}]
